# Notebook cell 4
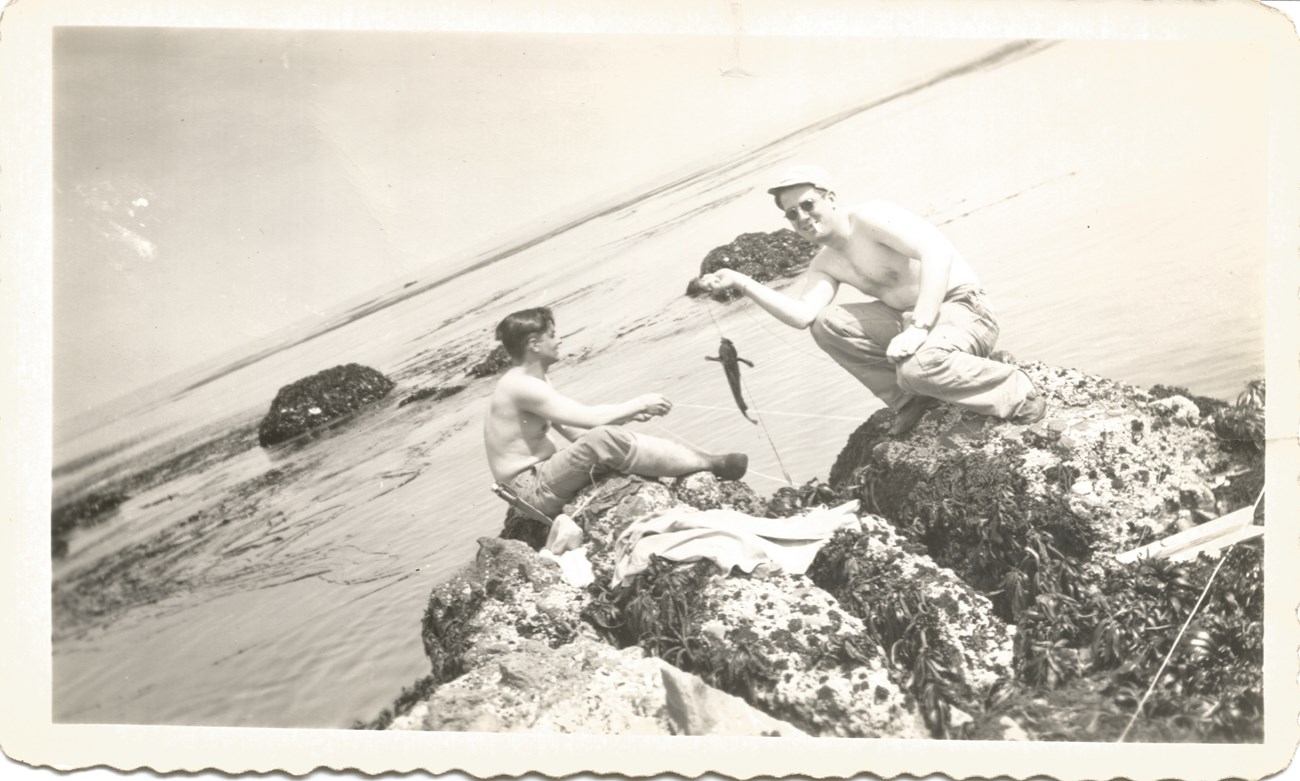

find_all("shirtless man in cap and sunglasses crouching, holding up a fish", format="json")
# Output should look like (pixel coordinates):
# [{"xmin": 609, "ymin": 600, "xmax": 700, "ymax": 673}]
[{"xmin": 699, "ymin": 165, "xmax": 1047, "ymax": 435}]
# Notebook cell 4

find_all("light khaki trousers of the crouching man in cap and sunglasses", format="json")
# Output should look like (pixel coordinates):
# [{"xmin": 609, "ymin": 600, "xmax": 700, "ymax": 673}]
[{"xmin": 811, "ymin": 287, "xmax": 1034, "ymax": 418}]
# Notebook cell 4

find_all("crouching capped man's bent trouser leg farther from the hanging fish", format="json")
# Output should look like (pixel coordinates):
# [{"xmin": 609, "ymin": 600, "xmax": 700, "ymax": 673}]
[{"xmin": 898, "ymin": 291, "xmax": 1034, "ymax": 418}]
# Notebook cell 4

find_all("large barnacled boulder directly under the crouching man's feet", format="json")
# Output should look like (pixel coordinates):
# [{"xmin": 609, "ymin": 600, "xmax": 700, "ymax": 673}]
[{"xmin": 831, "ymin": 364, "xmax": 1240, "ymax": 608}]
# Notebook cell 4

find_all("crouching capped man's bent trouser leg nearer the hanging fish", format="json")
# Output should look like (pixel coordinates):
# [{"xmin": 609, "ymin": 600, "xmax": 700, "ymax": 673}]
[{"xmin": 811, "ymin": 301, "xmax": 911, "ymax": 411}]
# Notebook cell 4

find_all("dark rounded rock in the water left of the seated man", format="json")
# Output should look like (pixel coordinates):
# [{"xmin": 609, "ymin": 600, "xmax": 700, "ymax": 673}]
[{"xmin": 257, "ymin": 364, "xmax": 394, "ymax": 447}]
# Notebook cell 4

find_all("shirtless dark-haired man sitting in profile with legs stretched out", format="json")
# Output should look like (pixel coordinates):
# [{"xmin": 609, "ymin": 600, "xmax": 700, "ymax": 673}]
[{"xmin": 484, "ymin": 307, "xmax": 749, "ymax": 552}]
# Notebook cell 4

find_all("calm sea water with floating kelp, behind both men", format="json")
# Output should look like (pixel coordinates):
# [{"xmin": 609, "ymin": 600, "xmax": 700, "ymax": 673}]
[{"xmin": 53, "ymin": 43, "xmax": 1266, "ymax": 726}]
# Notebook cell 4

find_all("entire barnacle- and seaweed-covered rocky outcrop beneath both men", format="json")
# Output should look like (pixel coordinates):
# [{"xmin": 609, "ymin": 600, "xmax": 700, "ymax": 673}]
[{"xmin": 374, "ymin": 364, "xmax": 1262, "ymax": 741}]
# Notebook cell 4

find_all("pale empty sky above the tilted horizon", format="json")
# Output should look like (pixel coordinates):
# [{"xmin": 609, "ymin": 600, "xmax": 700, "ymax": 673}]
[{"xmin": 53, "ymin": 27, "xmax": 996, "ymax": 420}]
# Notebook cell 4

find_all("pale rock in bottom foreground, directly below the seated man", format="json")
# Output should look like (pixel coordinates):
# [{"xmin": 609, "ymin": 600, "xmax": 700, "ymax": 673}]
[{"xmin": 410, "ymin": 538, "xmax": 798, "ymax": 736}]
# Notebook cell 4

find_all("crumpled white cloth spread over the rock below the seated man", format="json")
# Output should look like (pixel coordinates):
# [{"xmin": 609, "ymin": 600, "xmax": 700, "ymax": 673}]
[{"xmin": 611, "ymin": 500, "xmax": 858, "ymax": 587}]
